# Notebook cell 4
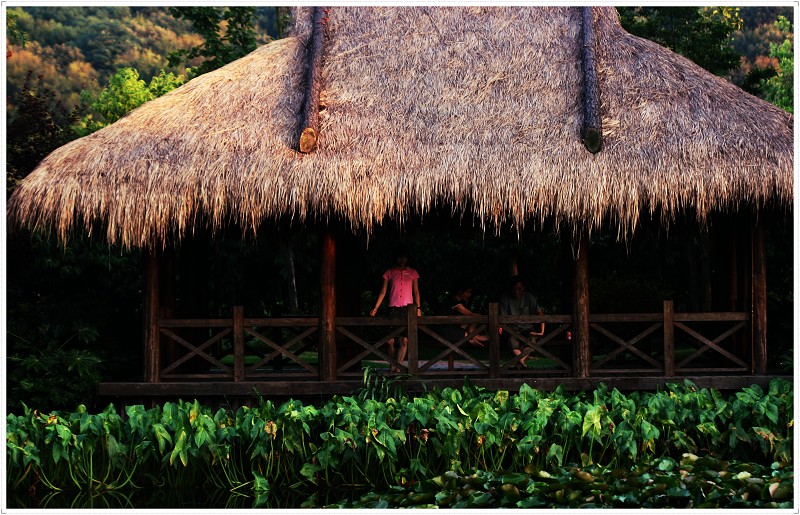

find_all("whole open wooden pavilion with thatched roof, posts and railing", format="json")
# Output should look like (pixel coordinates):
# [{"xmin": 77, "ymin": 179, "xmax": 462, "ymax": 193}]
[{"xmin": 8, "ymin": 6, "xmax": 794, "ymax": 404}]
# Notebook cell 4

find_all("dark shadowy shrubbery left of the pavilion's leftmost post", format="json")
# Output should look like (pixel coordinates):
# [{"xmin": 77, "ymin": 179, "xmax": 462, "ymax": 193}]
[{"xmin": 6, "ymin": 234, "xmax": 141, "ymax": 411}]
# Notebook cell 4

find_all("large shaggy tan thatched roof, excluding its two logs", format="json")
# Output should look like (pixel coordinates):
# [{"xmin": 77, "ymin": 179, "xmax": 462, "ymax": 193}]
[{"xmin": 8, "ymin": 7, "xmax": 793, "ymax": 250}]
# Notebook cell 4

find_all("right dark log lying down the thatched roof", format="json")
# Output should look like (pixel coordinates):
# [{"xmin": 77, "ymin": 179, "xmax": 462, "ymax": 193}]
[{"xmin": 581, "ymin": 7, "xmax": 603, "ymax": 154}]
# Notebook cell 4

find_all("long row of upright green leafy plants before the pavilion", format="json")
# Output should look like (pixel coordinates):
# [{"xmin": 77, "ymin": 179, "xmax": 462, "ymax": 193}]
[{"xmin": 6, "ymin": 379, "xmax": 794, "ymax": 505}]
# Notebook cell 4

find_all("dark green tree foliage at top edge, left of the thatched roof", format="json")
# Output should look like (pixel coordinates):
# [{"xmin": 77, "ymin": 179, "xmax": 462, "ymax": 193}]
[{"xmin": 169, "ymin": 7, "xmax": 257, "ymax": 78}]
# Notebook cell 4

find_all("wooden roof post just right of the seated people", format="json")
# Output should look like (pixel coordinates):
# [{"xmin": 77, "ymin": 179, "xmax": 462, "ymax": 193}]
[{"xmin": 572, "ymin": 229, "xmax": 592, "ymax": 378}]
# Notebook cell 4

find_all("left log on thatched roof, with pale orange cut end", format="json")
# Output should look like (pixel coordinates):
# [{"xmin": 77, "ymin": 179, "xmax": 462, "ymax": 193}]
[{"xmin": 298, "ymin": 7, "xmax": 328, "ymax": 154}]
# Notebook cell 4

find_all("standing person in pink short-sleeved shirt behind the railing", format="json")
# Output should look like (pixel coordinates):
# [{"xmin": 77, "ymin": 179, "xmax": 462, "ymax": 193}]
[{"xmin": 369, "ymin": 247, "xmax": 421, "ymax": 372}]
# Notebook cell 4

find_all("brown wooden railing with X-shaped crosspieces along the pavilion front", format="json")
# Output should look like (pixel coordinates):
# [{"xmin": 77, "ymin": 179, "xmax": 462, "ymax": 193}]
[{"xmin": 158, "ymin": 301, "xmax": 751, "ymax": 381}]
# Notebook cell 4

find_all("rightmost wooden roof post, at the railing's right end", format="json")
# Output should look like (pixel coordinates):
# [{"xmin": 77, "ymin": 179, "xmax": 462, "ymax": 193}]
[{"xmin": 751, "ymin": 219, "xmax": 767, "ymax": 376}]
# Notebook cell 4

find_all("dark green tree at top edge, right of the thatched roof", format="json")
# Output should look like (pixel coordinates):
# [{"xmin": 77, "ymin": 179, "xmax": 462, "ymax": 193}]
[{"xmin": 617, "ymin": 7, "xmax": 744, "ymax": 75}]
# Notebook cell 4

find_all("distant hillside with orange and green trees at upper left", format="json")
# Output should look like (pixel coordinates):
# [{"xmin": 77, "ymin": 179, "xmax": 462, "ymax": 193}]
[{"xmin": 7, "ymin": 6, "xmax": 278, "ymax": 115}]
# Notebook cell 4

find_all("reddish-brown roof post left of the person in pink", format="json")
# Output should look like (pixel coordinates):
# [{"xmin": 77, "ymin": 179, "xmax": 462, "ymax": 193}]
[{"xmin": 319, "ymin": 228, "xmax": 336, "ymax": 381}]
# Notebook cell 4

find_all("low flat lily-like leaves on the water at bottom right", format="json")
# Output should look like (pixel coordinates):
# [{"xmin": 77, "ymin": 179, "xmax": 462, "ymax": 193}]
[{"xmin": 327, "ymin": 462, "xmax": 794, "ymax": 508}]
